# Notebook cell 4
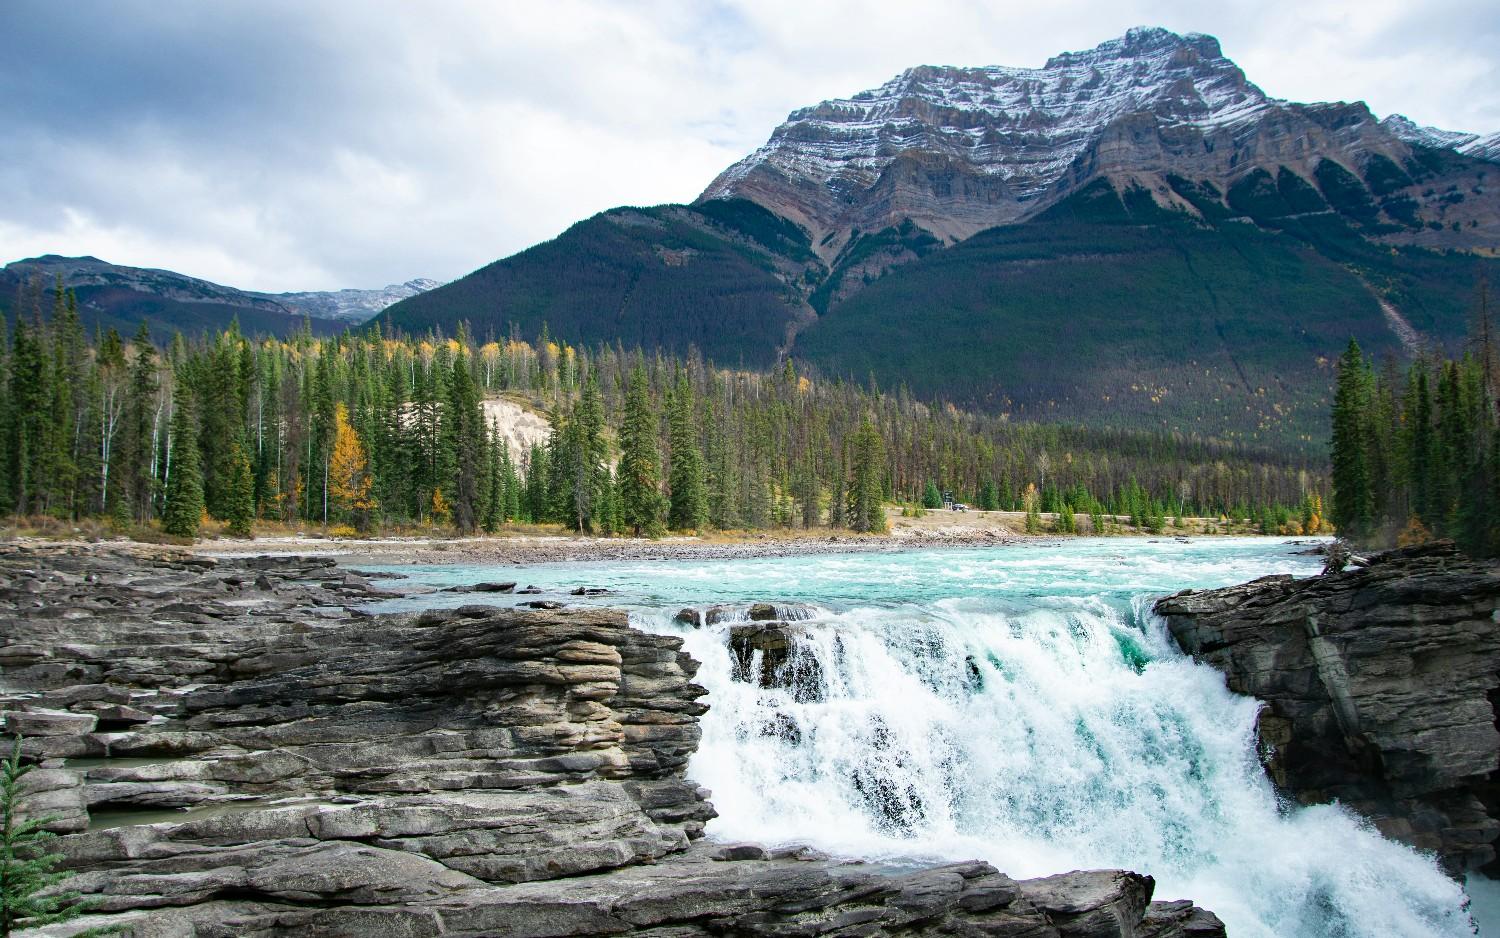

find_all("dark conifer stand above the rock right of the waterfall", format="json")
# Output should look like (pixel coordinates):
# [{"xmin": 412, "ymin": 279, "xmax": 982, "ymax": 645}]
[{"xmin": 1331, "ymin": 287, "xmax": 1500, "ymax": 557}]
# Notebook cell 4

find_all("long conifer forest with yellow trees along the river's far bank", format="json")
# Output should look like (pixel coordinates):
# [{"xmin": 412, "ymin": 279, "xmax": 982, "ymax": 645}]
[{"xmin": 0, "ymin": 277, "xmax": 1326, "ymax": 537}]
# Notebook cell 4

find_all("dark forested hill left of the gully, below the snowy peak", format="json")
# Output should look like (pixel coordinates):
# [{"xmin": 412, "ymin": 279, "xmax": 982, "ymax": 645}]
[{"xmin": 383, "ymin": 201, "xmax": 822, "ymax": 366}]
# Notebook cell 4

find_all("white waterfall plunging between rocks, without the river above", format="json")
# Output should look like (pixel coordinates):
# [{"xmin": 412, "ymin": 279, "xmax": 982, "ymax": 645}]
[{"xmin": 644, "ymin": 597, "xmax": 1472, "ymax": 938}]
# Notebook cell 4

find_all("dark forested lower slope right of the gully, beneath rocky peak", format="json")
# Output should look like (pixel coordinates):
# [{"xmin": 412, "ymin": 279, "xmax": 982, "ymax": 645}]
[{"xmin": 797, "ymin": 182, "xmax": 1500, "ymax": 449}]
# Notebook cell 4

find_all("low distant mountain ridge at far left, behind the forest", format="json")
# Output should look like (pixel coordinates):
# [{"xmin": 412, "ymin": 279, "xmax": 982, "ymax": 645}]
[{"xmin": 0, "ymin": 254, "xmax": 440, "ymax": 335}]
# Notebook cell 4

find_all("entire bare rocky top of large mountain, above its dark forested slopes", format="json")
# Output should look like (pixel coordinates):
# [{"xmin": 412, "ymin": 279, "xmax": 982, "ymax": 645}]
[{"xmin": 699, "ymin": 27, "xmax": 1500, "ymax": 261}]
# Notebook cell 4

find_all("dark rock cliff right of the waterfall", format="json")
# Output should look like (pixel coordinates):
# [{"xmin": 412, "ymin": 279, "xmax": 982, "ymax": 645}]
[{"xmin": 1157, "ymin": 543, "xmax": 1500, "ymax": 872}]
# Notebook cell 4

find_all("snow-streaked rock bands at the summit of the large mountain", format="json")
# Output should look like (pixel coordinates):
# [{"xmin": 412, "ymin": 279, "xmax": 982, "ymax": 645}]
[{"xmin": 702, "ymin": 27, "xmax": 1283, "ymax": 200}]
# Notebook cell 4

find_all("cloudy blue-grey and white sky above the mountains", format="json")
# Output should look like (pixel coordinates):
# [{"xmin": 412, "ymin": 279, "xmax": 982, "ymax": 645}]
[{"xmin": 0, "ymin": 0, "xmax": 1500, "ymax": 291}]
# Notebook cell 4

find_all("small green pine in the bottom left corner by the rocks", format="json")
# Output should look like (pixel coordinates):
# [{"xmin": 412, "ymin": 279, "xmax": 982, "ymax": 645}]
[{"xmin": 0, "ymin": 735, "xmax": 87, "ymax": 935}]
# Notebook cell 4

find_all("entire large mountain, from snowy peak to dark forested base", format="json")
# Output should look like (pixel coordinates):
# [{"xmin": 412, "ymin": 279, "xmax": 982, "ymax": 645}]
[{"xmin": 384, "ymin": 29, "xmax": 1500, "ymax": 446}]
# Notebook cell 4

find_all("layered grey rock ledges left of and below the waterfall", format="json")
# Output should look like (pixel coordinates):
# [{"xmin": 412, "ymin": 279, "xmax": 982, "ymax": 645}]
[{"xmin": 0, "ymin": 548, "xmax": 1223, "ymax": 938}]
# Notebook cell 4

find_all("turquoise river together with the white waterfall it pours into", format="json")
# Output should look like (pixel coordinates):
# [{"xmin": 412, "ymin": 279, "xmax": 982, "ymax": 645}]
[{"xmin": 372, "ymin": 539, "xmax": 1473, "ymax": 938}]
